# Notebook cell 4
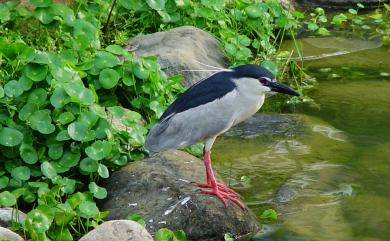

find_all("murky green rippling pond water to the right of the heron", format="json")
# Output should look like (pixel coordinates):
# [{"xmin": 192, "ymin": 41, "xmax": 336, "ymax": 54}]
[{"xmin": 213, "ymin": 39, "xmax": 390, "ymax": 241}]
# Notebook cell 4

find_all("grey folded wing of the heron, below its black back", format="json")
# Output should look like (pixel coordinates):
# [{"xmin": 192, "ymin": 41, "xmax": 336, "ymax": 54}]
[{"xmin": 145, "ymin": 91, "xmax": 236, "ymax": 152}]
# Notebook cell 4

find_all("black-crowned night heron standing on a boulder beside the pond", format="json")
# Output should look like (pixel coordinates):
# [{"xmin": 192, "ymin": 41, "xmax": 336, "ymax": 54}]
[{"xmin": 145, "ymin": 64, "xmax": 299, "ymax": 208}]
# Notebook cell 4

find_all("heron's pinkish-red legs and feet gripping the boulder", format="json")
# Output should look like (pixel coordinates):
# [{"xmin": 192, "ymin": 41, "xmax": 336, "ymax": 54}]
[{"xmin": 198, "ymin": 151, "xmax": 244, "ymax": 209}]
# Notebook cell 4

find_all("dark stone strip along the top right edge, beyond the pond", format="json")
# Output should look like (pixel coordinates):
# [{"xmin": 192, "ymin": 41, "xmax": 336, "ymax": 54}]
[{"xmin": 296, "ymin": 0, "xmax": 390, "ymax": 9}]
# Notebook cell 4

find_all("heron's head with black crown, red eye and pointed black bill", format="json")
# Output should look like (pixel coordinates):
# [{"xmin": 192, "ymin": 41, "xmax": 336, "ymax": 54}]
[{"xmin": 233, "ymin": 64, "xmax": 300, "ymax": 96}]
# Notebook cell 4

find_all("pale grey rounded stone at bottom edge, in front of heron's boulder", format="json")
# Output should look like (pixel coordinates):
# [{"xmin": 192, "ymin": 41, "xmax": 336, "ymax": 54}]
[{"xmin": 80, "ymin": 220, "xmax": 153, "ymax": 241}]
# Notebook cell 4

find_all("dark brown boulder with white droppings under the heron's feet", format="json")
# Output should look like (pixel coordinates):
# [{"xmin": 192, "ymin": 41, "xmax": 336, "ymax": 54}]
[{"xmin": 100, "ymin": 151, "xmax": 258, "ymax": 241}]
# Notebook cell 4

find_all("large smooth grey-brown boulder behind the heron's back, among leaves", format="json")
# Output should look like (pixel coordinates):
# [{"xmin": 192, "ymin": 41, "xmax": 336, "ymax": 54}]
[{"xmin": 126, "ymin": 26, "xmax": 226, "ymax": 87}]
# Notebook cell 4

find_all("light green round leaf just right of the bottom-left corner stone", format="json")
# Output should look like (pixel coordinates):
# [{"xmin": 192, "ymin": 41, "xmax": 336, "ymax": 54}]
[{"xmin": 24, "ymin": 209, "xmax": 52, "ymax": 233}]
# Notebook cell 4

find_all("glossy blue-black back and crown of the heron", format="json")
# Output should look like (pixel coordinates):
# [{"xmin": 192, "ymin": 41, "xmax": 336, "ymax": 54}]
[{"xmin": 161, "ymin": 64, "xmax": 274, "ymax": 120}]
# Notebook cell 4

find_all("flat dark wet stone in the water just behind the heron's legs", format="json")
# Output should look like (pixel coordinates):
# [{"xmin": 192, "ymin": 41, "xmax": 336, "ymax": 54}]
[{"xmin": 224, "ymin": 113, "xmax": 305, "ymax": 138}]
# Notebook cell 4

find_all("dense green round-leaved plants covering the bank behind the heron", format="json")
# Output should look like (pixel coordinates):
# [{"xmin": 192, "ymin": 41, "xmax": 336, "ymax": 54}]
[{"xmin": 0, "ymin": 0, "xmax": 354, "ymax": 240}]
